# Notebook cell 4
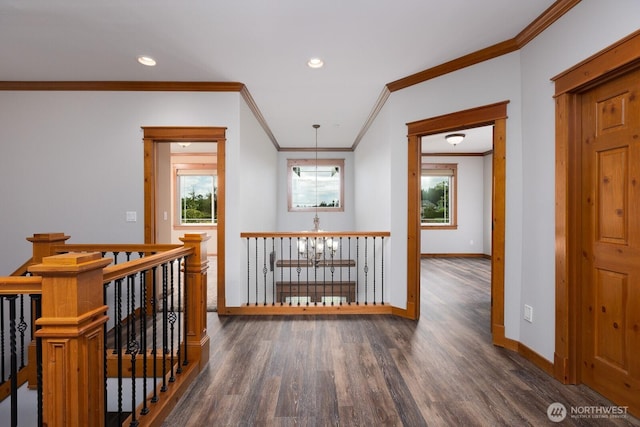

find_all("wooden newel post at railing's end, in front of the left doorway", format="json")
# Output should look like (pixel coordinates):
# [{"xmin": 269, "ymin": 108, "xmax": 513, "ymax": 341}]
[{"xmin": 180, "ymin": 233, "xmax": 210, "ymax": 370}]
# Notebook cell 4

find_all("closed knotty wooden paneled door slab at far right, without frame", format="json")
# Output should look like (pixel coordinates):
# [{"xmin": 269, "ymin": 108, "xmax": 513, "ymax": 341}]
[{"xmin": 579, "ymin": 67, "xmax": 640, "ymax": 413}]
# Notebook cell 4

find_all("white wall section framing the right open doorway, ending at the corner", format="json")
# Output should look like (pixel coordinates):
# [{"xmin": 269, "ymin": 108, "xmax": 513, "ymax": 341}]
[{"xmin": 364, "ymin": 52, "xmax": 522, "ymax": 324}]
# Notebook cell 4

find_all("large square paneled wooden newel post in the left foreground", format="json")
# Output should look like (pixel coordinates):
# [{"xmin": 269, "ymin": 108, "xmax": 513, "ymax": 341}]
[{"xmin": 29, "ymin": 252, "xmax": 111, "ymax": 427}]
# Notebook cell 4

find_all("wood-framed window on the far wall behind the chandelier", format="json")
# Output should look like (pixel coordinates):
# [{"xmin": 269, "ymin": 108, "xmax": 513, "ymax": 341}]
[{"xmin": 287, "ymin": 159, "xmax": 344, "ymax": 212}]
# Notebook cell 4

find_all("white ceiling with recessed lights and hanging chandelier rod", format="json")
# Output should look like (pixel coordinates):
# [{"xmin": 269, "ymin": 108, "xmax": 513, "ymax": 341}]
[{"xmin": 0, "ymin": 0, "xmax": 554, "ymax": 148}]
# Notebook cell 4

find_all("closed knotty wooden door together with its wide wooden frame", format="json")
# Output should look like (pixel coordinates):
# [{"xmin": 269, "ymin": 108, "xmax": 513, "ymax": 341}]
[{"xmin": 553, "ymin": 31, "xmax": 640, "ymax": 414}]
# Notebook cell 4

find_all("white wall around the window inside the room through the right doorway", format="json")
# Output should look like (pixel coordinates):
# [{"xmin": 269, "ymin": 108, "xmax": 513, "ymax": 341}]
[{"xmin": 420, "ymin": 156, "xmax": 486, "ymax": 254}]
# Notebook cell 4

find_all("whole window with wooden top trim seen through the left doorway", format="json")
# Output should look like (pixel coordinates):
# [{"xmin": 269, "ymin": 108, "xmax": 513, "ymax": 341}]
[{"xmin": 176, "ymin": 164, "xmax": 218, "ymax": 226}]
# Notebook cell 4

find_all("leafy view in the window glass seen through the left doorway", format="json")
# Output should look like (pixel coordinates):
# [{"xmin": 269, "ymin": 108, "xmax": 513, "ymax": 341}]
[{"xmin": 178, "ymin": 175, "xmax": 218, "ymax": 225}]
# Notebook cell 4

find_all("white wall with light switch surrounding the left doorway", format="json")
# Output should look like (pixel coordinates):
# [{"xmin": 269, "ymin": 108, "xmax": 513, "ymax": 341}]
[{"xmin": 0, "ymin": 91, "xmax": 240, "ymax": 274}]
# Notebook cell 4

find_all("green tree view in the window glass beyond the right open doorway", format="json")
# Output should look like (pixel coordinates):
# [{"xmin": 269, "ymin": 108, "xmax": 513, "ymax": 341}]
[{"xmin": 421, "ymin": 175, "xmax": 451, "ymax": 224}]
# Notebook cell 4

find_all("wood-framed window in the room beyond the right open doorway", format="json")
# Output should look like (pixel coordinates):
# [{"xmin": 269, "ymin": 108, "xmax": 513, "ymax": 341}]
[{"xmin": 420, "ymin": 163, "xmax": 458, "ymax": 228}]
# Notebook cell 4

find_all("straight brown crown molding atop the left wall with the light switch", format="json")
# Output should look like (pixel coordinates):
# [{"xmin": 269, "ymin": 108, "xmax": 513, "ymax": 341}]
[{"xmin": 0, "ymin": 81, "xmax": 245, "ymax": 92}]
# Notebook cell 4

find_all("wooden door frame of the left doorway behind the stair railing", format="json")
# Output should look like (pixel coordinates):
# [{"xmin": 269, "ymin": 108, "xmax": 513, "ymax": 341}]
[{"xmin": 142, "ymin": 126, "xmax": 227, "ymax": 310}]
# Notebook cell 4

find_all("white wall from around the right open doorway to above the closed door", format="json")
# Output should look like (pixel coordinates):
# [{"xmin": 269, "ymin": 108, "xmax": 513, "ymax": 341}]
[{"xmin": 358, "ymin": 0, "xmax": 640, "ymax": 361}]
